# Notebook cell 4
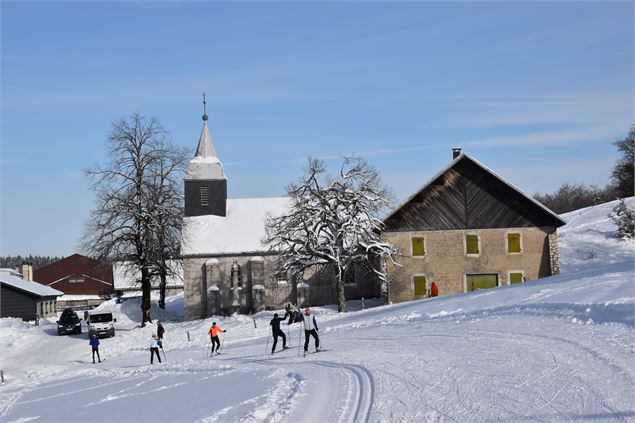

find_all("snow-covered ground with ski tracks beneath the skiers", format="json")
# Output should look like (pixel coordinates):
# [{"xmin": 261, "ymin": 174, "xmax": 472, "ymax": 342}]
[{"xmin": 0, "ymin": 199, "xmax": 635, "ymax": 422}]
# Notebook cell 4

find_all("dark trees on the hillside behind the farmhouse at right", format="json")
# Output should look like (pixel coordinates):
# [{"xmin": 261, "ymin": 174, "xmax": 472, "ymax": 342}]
[{"xmin": 534, "ymin": 125, "xmax": 635, "ymax": 214}]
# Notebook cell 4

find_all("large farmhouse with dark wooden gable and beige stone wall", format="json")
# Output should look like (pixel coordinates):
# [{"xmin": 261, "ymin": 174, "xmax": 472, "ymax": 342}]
[{"xmin": 382, "ymin": 149, "xmax": 565, "ymax": 302}]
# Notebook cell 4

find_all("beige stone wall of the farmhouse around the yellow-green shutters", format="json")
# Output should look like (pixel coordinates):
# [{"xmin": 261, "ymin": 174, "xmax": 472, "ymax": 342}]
[{"xmin": 382, "ymin": 228, "xmax": 557, "ymax": 302}]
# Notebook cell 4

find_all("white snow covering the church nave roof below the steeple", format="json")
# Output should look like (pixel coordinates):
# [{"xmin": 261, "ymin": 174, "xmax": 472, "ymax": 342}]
[{"xmin": 181, "ymin": 197, "xmax": 290, "ymax": 256}]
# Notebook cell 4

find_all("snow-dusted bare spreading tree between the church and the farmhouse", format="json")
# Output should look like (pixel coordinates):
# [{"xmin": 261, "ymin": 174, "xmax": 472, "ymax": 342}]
[{"xmin": 263, "ymin": 157, "xmax": 396, "ymax": 312}]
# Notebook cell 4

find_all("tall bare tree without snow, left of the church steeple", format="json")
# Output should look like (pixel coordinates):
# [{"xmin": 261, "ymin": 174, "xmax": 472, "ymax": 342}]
[{"xmin": 83, "ymin": 113, "xmax": 186, "ymax": 326}]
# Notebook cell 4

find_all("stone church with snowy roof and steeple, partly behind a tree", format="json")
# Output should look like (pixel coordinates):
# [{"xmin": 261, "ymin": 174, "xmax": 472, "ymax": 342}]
[{"xmin": 181, "ymin": 114, "xmax": 379, "ymax": 320}]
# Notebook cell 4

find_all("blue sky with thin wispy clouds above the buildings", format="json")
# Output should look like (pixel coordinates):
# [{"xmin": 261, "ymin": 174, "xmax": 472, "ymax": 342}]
[{"xmin": 0, "ymin": 1, "xmax": 635, "ymax": 256}]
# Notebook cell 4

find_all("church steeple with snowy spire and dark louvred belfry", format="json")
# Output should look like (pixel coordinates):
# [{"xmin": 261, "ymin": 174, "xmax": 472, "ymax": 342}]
[{"xmin": 184, "ymin": 93, "xmax": 227, "ymax": 216}]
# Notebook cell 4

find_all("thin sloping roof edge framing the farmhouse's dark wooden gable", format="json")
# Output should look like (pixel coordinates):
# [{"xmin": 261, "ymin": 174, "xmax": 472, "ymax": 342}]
[{"xmin": 383, "ymin": 153, "xmax": 566, "ymax": 229}]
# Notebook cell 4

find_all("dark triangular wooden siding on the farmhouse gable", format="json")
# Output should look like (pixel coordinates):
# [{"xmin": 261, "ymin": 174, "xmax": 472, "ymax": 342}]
[{"xmin": 384, "ymin": 157, "xmax": 562, "ymax": 232}]
